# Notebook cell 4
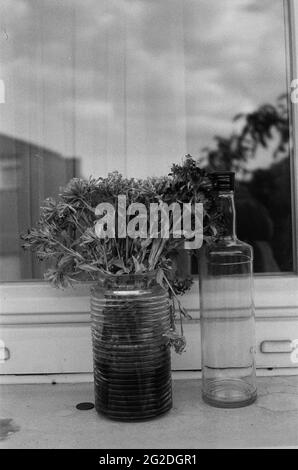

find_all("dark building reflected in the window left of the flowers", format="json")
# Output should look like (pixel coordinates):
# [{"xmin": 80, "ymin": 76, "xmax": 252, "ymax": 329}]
[{"xmin": 0, "ymin": 134, "xmax": 78, "ymax": 281}]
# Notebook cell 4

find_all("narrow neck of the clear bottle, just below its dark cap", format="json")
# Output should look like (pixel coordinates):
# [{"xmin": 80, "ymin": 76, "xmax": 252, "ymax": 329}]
[{"xmin": 218, "ymin": 191, "xmax": 236, "ymax": 240}]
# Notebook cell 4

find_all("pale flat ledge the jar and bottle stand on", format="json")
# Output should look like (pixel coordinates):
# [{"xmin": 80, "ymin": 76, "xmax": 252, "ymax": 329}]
[{"xmin": 0, "ymin": 376, "xmax": 298, "ymax": 449}]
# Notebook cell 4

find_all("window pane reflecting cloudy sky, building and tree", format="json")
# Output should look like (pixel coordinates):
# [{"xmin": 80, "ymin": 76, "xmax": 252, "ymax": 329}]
[{"xmin": 0, "ymin": 0, "xmax": 293, "ymax": 280}]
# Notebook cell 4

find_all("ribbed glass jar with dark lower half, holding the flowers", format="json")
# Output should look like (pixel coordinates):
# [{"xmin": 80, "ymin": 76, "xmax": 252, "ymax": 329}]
[{"xmin": 91, "ymin": 272, "xmax": 172, "ymax": 421}]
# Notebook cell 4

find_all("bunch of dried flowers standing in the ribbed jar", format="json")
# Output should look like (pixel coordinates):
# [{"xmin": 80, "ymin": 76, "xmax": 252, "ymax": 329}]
[{"xmin": 22, "ymin": 159, "xmax": 216, "ymax": 352}]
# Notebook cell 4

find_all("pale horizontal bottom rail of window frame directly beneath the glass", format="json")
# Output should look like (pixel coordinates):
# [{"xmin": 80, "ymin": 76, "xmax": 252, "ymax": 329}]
[{"xmin": 0, "ymin": 274, "xmax": 298, "ymax": 324}]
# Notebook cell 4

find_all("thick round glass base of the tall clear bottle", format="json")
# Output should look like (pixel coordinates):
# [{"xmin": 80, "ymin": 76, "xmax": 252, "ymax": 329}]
[{"xmin": 202, "ymin": 379, "xmax": 257, "ymax": 408}]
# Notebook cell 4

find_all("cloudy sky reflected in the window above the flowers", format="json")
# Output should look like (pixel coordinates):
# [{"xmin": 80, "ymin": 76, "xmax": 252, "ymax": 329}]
[{"xmin": 0, "ymin": 0, "xmax": 286, "ymax": 176}]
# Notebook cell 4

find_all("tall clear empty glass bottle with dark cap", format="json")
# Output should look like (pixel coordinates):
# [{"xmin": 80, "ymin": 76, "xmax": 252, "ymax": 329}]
[{"xmin": 199, "ymin": 171, "xmax": 257, "ymax": 408}]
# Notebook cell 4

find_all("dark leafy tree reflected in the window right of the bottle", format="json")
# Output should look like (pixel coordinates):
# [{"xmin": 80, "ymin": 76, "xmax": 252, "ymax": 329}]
[{"xmin": 198, "ymin": 94, "xmax": 293, "ymax": 272}]
